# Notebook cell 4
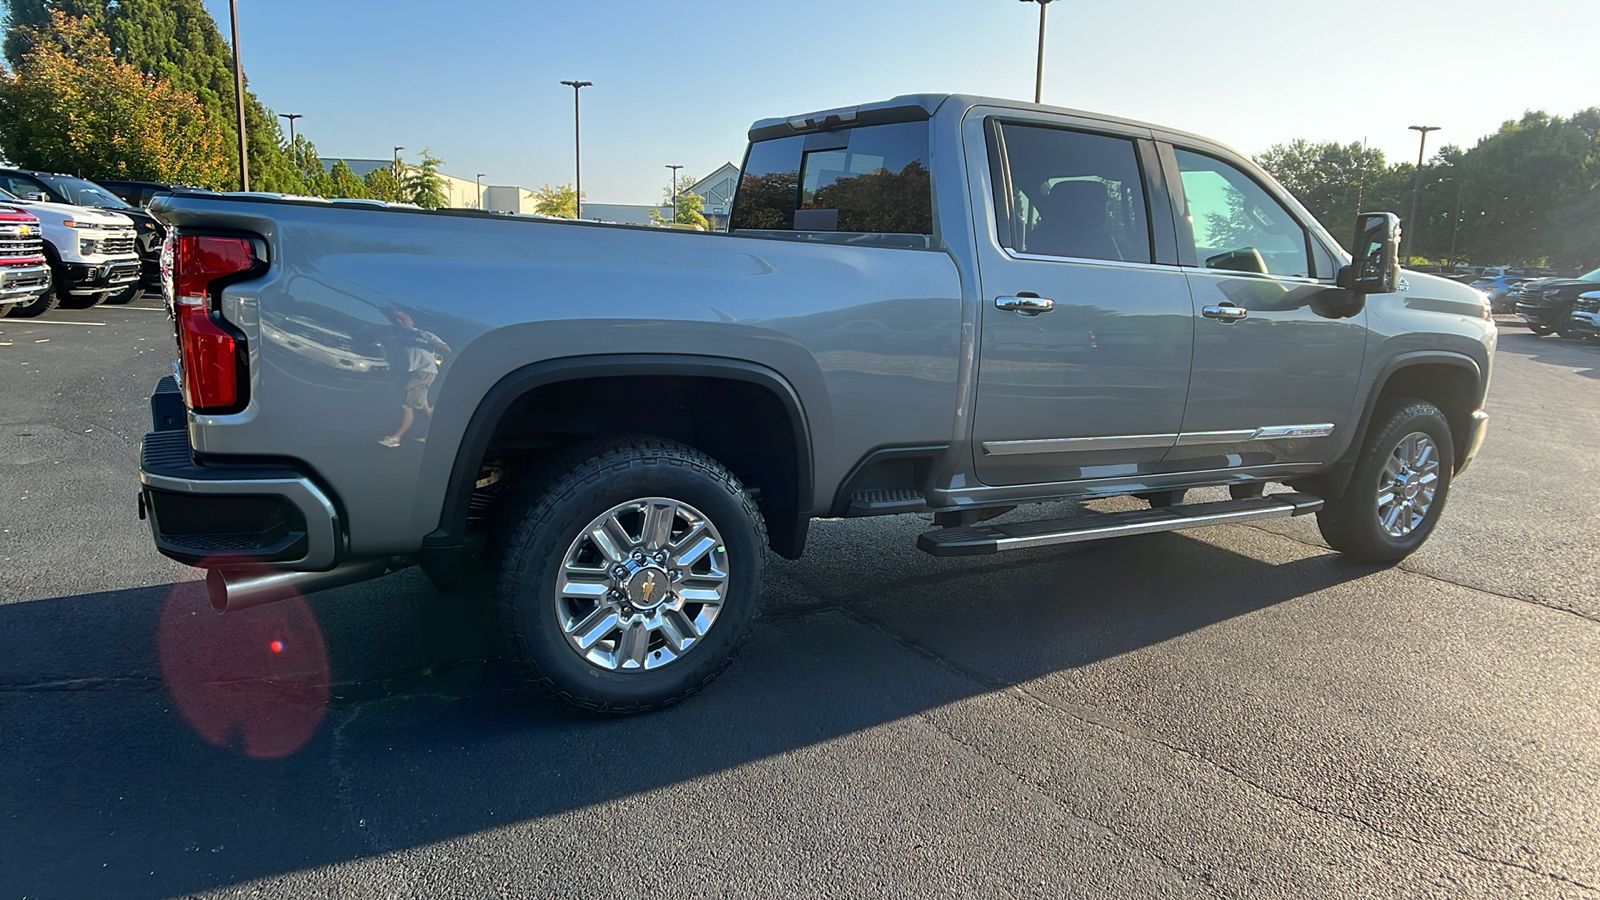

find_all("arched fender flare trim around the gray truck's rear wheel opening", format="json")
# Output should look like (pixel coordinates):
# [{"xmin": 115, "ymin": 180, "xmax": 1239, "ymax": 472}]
[{"xmin": 418, "ymin": 354, "xmax": 816, "ymax": 591}]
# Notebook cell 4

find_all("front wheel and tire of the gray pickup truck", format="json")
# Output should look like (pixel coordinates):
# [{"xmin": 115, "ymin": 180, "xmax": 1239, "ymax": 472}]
[{"xmin": 1317, "ymin": 397, "xmax": 1456, "ymax": 562}]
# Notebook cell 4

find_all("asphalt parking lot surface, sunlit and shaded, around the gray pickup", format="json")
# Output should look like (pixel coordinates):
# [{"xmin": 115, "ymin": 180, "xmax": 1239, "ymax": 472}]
[{"xmin": 0, "ymin": 301, "xmax": 1600, "ymax": 898}]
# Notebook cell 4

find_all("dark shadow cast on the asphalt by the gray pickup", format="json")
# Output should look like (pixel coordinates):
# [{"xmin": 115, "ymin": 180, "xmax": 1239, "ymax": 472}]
[{"xmin": 0, "ymin": 520, "xmax": 1374, "ymax": 897}]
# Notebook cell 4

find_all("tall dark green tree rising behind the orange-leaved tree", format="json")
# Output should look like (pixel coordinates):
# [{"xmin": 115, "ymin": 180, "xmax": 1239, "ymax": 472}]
[{"xmin": 5, "ymin": 0, "xmax": 306, "ymax": 192}]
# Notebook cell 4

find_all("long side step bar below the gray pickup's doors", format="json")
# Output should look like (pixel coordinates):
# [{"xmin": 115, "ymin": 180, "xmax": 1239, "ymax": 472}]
[{"xmin": 917, "ymin": 493, "xmax": 1322, "ymax": 556}]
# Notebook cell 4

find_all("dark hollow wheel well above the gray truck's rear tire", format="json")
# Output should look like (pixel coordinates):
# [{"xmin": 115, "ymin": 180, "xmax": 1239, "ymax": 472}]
[{"xmin": 469, "ymin": 375, "xmax": 805, "ymax": 556}]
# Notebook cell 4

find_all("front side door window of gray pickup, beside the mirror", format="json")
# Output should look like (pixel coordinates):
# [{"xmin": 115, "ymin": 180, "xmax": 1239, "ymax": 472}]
[{"xmin": 1176, "ymin": 149, "xmax": 1310, "ymax": 277}]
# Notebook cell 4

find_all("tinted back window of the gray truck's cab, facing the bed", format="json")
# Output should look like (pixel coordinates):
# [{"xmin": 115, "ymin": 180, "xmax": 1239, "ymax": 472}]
[{"xmin": 730, "ymin": 122, "xmax": 933, "ymax": 235}]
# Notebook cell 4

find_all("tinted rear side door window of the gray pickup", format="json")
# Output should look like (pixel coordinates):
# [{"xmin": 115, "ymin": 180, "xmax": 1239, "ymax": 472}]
[{"xmin": 995, "ymin": 125, "xmax": 1152, "ymax": 263}]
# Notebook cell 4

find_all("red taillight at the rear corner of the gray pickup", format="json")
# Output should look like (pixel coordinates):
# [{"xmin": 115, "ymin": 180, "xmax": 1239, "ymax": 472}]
[{"xmin": 172, "ymin": 234, "xmax": 259, "ymax": 413}]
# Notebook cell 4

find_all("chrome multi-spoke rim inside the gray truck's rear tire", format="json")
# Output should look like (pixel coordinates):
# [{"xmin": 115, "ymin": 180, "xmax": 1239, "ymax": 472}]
[{"xmin": 555, "ymin": 496, "xmax": 728, "ymax": 673}]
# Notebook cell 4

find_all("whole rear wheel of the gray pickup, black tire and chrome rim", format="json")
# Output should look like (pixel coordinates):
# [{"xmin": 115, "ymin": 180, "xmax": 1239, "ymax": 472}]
[{"xmin": 498, "ymin": 437, "xmax": 768, "ymax": 714}]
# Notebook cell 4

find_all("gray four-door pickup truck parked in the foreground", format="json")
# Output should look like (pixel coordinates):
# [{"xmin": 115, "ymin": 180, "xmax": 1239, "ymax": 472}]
[{"xmin": 139, "ymin": 96, "xmax": 1496, "ymax": 711}]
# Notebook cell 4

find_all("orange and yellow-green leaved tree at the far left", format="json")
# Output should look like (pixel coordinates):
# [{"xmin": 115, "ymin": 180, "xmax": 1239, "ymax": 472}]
[{"xmin": 0, "ymin": 11, "xmax": 230, "ymax": 187}]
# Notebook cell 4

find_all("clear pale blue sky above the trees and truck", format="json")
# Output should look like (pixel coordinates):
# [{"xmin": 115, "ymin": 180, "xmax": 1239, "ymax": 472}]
[{"xmin": 206, "ymin": 0, "xmax": 1600, "ymax": 203}]
